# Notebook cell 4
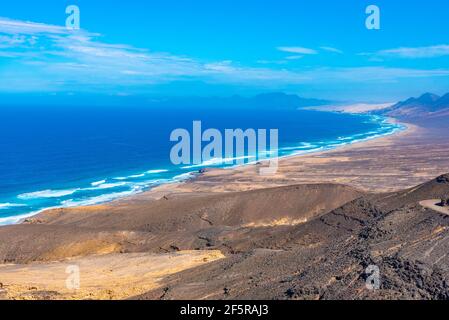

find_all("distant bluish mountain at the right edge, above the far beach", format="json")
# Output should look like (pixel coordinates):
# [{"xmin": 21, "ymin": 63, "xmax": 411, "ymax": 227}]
[{"xmin": 381, "ymin": 93, "xmax": 449, "ymax": 119}]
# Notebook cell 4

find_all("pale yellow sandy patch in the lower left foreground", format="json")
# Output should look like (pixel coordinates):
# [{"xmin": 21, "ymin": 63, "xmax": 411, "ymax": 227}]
[{"xmin": 0, "ymin": 250, "xmax": 224, "ymax": 300}]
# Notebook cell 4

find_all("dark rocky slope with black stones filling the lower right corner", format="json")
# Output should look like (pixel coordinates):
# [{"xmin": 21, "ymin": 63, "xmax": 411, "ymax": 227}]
[{"xmin": 134, "ymin": 175, "xmax": 449, "ymax": 299}]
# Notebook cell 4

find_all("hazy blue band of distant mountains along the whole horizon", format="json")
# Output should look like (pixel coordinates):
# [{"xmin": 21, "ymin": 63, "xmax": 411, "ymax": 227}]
[{"xmin": 0, "ymin": 92, "xmax": 449, "ymax": 121}]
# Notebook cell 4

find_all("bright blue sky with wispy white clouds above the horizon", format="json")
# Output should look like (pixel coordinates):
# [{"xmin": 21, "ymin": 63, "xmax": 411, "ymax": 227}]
[{"xmin": 0, "ymin": 0, "xmax": 449, "ymax": 102}]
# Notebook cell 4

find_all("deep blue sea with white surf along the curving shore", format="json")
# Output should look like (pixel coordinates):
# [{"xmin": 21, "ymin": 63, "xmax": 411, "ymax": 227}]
[{"xmin": 0, "ymin": 107, "xmax": 400, "ymax": 224}]
